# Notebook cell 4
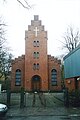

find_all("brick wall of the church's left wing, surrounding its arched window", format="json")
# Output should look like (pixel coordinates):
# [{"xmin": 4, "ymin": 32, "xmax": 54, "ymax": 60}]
[{"xmin": 11, "ymin": 55, "xmax": 25, "ymax": 90}]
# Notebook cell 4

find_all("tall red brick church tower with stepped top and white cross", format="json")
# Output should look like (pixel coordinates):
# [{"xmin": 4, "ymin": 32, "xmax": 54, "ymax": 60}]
[{"xmin": 25, "ymin": 15, "xmax": 48, "ymax": 91}]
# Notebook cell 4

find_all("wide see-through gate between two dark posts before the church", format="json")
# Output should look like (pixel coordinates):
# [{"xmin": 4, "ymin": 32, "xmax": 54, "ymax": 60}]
[{"xmin": 25, "ymin": 92, "xmax": 64, "ymax": 107}]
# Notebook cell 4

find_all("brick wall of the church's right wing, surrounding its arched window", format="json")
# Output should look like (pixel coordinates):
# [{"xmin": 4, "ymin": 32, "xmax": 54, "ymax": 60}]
[{"xmin": 48, "ymin": 55, "xmax": 61, "ymax": 90}]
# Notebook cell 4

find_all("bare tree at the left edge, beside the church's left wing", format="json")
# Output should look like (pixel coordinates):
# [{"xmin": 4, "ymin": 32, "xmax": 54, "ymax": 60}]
[{"xmin": 0, "ymin": 18, "xmax": 12, "ymax": 79}]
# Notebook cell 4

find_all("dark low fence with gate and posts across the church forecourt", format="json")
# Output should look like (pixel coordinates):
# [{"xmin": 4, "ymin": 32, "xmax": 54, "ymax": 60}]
[{"xmin": 0, "ymin": 89, "xmax": 69, "ymax": 107}]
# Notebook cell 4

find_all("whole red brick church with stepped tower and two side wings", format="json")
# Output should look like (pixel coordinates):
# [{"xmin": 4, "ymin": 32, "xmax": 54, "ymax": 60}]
[{"xmin": 11, "ymin": 15, "xmax": 61, "ymax": 91}]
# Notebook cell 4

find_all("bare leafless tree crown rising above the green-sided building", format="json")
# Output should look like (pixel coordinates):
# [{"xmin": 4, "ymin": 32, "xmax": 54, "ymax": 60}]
[{"xmin": 62, "ymin": 27, "xmax": 80, "ymax": 52}]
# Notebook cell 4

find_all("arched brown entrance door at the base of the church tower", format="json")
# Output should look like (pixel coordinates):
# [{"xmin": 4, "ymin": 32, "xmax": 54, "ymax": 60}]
[{"xmin": 32, "ymin": 75, "xmax": 41, "ymax": 91}]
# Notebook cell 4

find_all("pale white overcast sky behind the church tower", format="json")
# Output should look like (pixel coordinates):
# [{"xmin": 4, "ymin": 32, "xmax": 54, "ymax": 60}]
[{"xmin": 0, "ymin": 0, "xmax": 80, "ymax": 57}]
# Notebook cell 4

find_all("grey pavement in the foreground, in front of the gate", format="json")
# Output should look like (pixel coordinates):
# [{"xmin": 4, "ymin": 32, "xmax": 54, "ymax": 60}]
[{"xmin": 6, "ymin": 107, "xmax": 80, "ymax": 120}]
